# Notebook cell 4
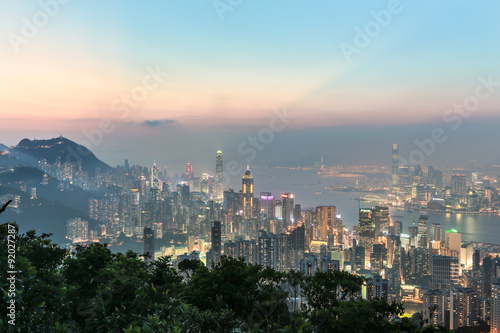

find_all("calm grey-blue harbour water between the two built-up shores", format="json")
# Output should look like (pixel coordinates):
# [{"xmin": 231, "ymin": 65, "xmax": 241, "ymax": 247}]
[{"xmin": 248, "ymin": 168, "xmax": 500, "ymax": 244}]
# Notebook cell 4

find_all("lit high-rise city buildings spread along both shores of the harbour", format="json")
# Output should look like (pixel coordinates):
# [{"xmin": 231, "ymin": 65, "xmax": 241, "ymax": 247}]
[{"xmin": 6, "ymin": 141, "xmax": 500, "ymax": 333}]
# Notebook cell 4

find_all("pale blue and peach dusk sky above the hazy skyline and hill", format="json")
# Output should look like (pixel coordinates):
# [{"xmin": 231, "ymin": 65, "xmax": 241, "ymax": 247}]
[{"xmin": 0, "ymin": 0, "xmax": 500, "ymax": 172}]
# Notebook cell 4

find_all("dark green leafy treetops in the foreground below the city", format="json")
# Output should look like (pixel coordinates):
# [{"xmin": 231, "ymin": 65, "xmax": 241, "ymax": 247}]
[{"xmin": 0, "ymin": 223, "xmax": 454, "ymax": 333}]
